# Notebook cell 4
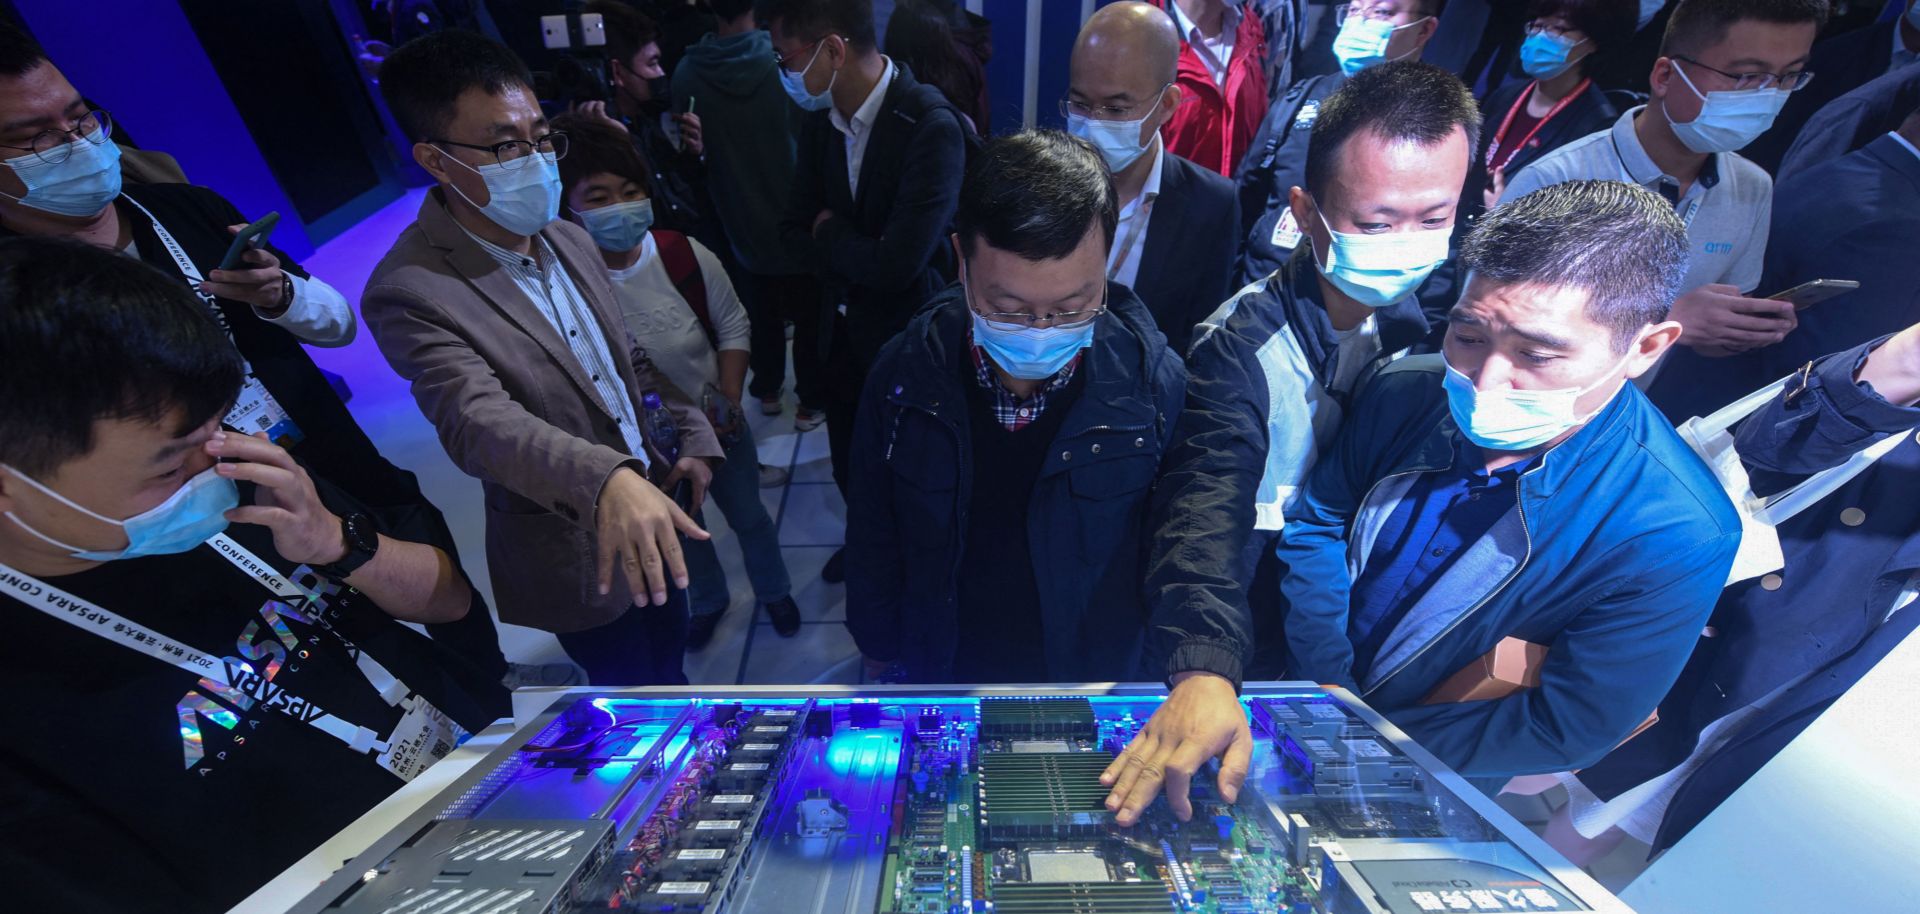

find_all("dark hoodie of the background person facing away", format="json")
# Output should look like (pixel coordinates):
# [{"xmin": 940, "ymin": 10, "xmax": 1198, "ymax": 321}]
[{"xmin": 674, "ymin": 29, "xmax": 806, "ymax": 275}]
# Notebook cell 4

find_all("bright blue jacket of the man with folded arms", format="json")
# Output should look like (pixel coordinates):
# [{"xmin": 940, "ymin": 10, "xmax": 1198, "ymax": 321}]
[{"xmin": 1279, "ymin": 355, "xmax": 1740, "ymax": 783}]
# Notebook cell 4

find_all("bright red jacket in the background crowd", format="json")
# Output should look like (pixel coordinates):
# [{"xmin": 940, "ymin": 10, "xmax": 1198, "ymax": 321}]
[{"xmin": 1156, "ymin": 0, "xmax": 1267, "ymax": 179}]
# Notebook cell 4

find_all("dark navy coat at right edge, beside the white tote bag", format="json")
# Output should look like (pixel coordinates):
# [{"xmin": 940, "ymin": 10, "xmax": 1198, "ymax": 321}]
[{"xmin": 1580, "ymin": 340, "xmax": 1920, "ymax": 851}]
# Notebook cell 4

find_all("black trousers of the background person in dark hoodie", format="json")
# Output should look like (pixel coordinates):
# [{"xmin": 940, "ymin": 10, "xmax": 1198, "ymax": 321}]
[{"xmin": 735, "ymin": 269, "xmax": 828, "ymax": 409}]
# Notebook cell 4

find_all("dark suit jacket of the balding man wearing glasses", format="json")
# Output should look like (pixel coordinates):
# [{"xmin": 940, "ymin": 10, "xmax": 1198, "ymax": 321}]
[{"xmin": 1133, "ymin": 152, "xmax": 1240, "ymax": 359}]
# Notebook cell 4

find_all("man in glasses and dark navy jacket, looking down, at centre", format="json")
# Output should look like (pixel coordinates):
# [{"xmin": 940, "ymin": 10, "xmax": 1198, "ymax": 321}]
[{"xmin": 847, "ymin": 131, "xmax": 1187, "ymax": 682}]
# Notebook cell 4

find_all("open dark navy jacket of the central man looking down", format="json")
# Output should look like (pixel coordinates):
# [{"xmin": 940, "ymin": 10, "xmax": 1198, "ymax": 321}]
[{"xmin": 847, "ymin": 282, "xmax": 1187, "ymax": 682}]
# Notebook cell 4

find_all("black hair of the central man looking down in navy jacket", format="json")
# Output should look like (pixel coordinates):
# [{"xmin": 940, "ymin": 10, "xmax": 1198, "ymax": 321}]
[{"xmin": 954, "ymin": 131, "xmax": 1119, "ymax": 261}]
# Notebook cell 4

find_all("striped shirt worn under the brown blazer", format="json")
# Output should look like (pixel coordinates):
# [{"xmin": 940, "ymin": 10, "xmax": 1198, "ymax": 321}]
[{"xmin": 461, "ymin": 227, "xmax": 651, "ymax": 465}]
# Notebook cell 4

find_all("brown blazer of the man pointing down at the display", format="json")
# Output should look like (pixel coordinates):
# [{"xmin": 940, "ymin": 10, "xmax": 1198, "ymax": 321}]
[{"xmin": 361, "ymin": 188, "xmax": 722, "ymax": 632}]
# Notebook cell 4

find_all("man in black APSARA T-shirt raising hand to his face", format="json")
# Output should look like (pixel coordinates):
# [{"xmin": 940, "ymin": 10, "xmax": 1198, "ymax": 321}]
[{"xmin": 0, "ymin": 238, "xmax": 507, "ymax": 912}]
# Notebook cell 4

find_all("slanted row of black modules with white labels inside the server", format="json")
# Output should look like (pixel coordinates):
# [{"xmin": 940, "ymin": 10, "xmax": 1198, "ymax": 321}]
[{"xmin": 609, "ymin": 703, "xmax": 812, "ymax": 914}]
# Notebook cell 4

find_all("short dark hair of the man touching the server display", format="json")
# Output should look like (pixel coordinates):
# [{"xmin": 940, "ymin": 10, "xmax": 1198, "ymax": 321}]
[{"xmin": 1306, "ymin": 60, "xmax": 1480, "ymax": 200}]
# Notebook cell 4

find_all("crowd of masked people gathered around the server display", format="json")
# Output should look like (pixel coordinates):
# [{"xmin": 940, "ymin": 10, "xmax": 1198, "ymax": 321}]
[{"xmin": 0, "ymin": 0, "xmax": 1920, "ymax": 912}]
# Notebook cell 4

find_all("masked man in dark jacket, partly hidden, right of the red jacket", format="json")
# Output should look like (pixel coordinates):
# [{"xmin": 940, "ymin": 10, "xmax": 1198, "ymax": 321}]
[{"xmin": 1233, "ymin": 0, "xmax": 1446, "ymax": 284}]
